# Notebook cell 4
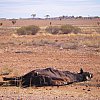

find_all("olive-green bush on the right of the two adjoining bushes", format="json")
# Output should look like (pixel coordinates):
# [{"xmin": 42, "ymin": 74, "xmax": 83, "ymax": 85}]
[{"xmin": 61, "ymin": 24, "xmax": 80, "ymax": 34}]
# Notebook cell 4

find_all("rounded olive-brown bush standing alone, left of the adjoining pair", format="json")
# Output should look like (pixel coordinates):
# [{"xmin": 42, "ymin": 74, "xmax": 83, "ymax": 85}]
[{"xmin": 17, "ymin": 25, "xmax": 40, "ymax": 35}]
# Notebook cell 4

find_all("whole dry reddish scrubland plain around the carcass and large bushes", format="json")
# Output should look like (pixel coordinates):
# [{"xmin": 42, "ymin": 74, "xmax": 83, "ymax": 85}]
[{"xmin": 0, "ymin": 19, "xmax": 100, "ymax": 100}]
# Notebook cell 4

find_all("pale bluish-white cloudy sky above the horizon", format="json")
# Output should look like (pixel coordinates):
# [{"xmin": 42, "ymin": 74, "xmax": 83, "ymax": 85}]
[{"xmin": 0, "ymin": 0, "xmax": 100, "ymax": 18}]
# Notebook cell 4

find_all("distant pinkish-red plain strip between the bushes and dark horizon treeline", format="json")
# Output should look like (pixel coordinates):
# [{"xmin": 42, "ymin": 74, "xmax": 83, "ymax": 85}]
[{"xmin": 0, "ymin": 18, "xmax": 100, "ymax": 27}]
